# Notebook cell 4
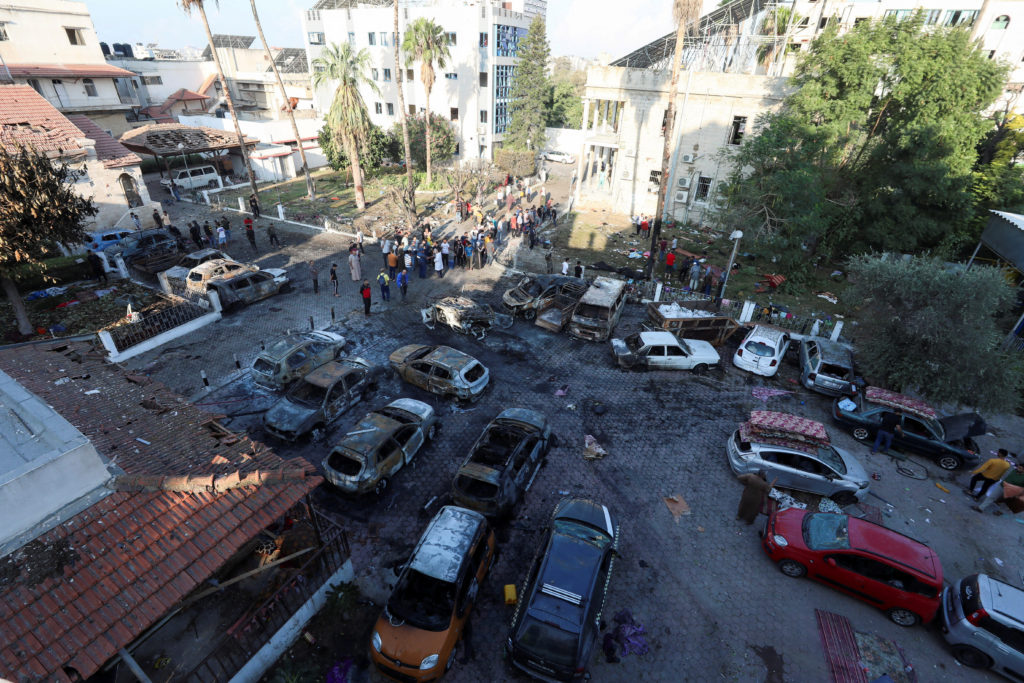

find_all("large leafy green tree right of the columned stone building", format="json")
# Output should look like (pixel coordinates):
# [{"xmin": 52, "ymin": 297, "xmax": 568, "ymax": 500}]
[{"xmin": 721, "ymin": 12, "xmax": 1007, "ymax": 280}]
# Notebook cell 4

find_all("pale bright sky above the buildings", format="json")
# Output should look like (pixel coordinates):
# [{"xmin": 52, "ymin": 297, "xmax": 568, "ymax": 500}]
[{"xmin": 86, "ymin": 0, "xmax": 673, "ymax": 57}]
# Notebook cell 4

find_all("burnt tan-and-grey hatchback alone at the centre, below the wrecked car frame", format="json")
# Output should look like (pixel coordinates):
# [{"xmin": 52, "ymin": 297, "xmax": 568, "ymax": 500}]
[{"xmin": 388, "ymin": 344, "xmax": 490, "ymax": 400}]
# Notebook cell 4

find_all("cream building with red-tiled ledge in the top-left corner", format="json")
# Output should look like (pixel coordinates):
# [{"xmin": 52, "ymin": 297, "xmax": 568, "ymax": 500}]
[{"xmin": 0, "ymin": 0, "xmax": 140, "ymax": 137}]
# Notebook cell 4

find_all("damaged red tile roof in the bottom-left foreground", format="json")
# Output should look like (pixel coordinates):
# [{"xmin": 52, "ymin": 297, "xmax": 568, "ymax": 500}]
[{"xmin": 0, "ymin": 343, "xmax": 321, "ymax": 681}]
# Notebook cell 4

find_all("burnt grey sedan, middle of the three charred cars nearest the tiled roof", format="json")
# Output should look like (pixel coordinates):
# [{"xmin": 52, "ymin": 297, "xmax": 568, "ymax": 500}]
[{"xmin": 263, "ymin": 356, "xmax": 378, "ymax": 441}]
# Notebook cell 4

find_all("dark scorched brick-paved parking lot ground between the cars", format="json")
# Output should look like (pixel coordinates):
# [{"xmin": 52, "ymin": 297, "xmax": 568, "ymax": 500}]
[{"xmin": 117, "ymin": 210, "xmax": 1020, "ymax": 681}]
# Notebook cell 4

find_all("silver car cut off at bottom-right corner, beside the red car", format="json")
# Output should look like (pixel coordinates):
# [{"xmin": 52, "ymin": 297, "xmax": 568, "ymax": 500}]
[{"xmin": 940, "ymin": 573, "xmax": 1024, "ymax": 681}]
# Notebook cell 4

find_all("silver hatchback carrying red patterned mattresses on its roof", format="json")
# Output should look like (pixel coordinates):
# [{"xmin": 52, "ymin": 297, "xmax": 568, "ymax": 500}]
[{"xmin": 726, "ymin": 429, "xmax": 870, "ymax": 505}]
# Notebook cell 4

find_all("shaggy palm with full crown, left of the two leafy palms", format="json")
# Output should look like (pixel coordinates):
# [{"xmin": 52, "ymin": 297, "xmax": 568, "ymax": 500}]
[{"xmin": 312, "ymin": 43, "xmax": 380, "ymax": 211}]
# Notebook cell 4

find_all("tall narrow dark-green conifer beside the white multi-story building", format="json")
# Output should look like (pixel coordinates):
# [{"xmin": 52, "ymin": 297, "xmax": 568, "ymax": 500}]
[{"xmin": 505, "ymin": 14, "xmax": 551, "ymax": 150}]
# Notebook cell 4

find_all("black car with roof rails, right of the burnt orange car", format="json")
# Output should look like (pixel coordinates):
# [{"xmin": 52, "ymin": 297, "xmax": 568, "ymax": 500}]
[{"xmin": 506, "ymin": 499, "xmax": 618, "ymax": 681}]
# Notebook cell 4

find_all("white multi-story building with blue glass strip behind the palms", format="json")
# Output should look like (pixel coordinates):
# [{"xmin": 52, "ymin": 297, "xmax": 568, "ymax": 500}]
[{"xmin": 302, "ymin": 0, "xmax": 547, "ymax": 161}]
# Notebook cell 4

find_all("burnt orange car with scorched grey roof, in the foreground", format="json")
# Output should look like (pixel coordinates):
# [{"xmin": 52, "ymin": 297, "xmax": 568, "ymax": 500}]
[{"xmin": 370, "ymin": 505, "xmax": 497, "ymax": 681}]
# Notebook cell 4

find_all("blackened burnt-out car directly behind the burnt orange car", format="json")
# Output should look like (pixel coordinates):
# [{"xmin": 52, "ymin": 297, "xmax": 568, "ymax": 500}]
[{"xmin": 452, "ymin": 408, "xmax": 553, "ymax": 517}]
